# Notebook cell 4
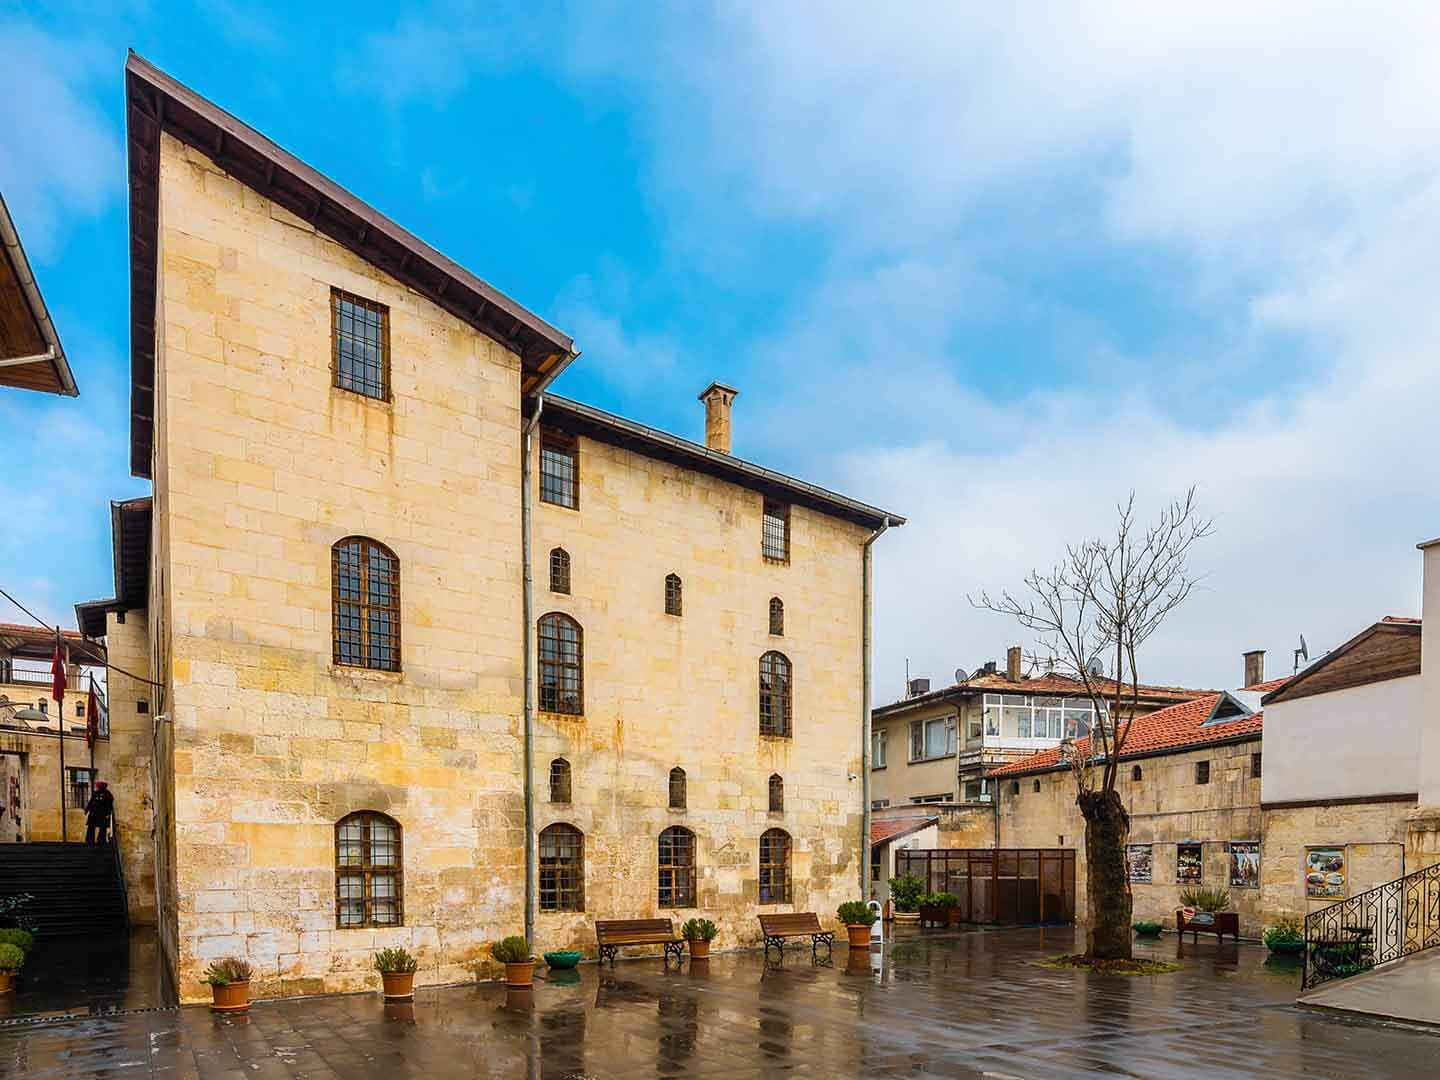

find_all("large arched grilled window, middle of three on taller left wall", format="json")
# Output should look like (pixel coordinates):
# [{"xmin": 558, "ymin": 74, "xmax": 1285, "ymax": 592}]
[{"xmin": 330, "ymin": 536, "xmax": 400, "ymax": 671}]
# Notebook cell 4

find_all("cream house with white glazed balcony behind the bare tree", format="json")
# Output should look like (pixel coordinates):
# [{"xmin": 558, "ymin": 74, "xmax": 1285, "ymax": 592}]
[{"xmin": 870, "ymin": 647, "xmax": 1212, "ymax": 811}]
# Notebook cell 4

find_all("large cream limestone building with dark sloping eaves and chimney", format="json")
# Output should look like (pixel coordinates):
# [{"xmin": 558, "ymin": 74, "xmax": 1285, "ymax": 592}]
[{"xmin": 85, "ymin": 56, "xmax": 903, "ymax": 999}]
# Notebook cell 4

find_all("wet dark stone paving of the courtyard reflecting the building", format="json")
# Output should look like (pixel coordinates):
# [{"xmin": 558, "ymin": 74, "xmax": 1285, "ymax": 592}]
[{"xmin": 0, "ymin": 930, "xmax": 1440, "ymax": 1080}]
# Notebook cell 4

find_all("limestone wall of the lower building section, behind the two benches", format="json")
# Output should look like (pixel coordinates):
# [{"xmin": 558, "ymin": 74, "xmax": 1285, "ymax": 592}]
[{"xmin": 534, "ymin": 439, "xmax": 865, "ymax": 950}]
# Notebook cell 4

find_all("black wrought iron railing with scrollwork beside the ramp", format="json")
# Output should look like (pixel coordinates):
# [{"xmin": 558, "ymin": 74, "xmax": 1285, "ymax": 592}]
[{"xmin": 1300, "ymin": 864, "xmax": 1440, "ymax": 989}]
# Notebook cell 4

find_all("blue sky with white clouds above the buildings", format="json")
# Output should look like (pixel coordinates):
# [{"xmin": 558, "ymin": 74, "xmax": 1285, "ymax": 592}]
[{"xmin": 0, "ymin": 0, "xmax": 1440, "ymax": 700}]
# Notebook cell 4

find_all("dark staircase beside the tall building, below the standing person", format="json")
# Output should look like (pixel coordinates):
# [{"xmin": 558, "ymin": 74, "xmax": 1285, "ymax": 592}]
[{"xmin": 0, "ymin": 842, "xmax": 130, "ymax": 937}]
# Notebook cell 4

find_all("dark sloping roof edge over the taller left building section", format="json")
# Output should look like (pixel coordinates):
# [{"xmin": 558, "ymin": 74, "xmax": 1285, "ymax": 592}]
[{"xmin": 125, "ymin": 53, "xmax": 576, "ymax": 477}]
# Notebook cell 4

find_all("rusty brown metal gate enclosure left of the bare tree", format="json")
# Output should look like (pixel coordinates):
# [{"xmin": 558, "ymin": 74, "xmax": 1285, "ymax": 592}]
[{"xmin": 896, "ymin": 848, "xmax": 1076, "ymax": 924}]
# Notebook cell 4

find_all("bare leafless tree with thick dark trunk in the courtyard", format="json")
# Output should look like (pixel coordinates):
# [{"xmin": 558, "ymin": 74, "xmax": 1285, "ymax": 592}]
[{"xmin": 971, "ymin": 488, "xmax": 1214, "ymax": 960}]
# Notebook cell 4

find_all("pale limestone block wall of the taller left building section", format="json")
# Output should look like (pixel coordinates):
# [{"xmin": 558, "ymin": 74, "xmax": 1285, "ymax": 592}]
[{"xmin": 151, "ymin": 135, "xmax": 523, "ymax": 1001}]
